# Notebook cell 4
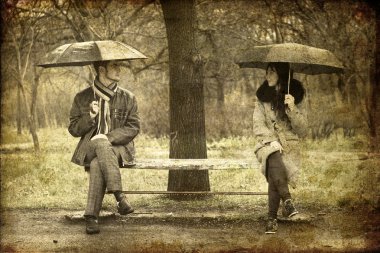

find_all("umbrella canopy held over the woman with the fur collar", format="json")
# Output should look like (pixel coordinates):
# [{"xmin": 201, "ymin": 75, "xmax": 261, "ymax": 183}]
[{"xmin": 237, "ymin": 43, "xmax": 343, "ymax": 75}]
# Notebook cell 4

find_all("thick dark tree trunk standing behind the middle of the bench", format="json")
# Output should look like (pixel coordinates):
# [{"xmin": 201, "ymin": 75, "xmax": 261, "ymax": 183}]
[{"xmin": 161, "ymin": 0, "xmax": 210, "ymax": 194}]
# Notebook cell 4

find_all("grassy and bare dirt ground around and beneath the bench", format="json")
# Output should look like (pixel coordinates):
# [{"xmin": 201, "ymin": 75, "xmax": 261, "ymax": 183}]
[{"xmin": 0, "ymin": 129, "xmax": 380, "ymax": 253}]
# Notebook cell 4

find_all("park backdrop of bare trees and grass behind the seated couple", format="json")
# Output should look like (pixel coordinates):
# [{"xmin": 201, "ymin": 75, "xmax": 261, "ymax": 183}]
[{"xmin": 1, "ymin": 0, "xmax": 380, "ymax": 253}]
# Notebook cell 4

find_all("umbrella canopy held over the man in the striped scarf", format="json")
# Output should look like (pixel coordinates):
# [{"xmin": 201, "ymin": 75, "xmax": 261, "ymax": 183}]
[{"xmin": 38, "ymin": 40, "xmax": 147, "ymax": 67}]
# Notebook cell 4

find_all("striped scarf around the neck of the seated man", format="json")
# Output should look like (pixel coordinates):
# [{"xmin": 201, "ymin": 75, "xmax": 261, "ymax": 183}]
[{"xmin": 93, "ymin": 78, "xmax": 117, "ymax": 134}]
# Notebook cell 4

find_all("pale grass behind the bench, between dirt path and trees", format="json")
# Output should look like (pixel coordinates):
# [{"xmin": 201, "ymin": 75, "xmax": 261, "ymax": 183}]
[{"xmin": 1, "ymin": 129, "xmax": 380, "ymax": 210}]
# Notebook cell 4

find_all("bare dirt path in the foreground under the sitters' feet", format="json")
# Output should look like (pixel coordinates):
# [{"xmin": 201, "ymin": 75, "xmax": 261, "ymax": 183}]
[{"xmin": 1, "ymin": 207, "xmax": 380, "ymax": 253}]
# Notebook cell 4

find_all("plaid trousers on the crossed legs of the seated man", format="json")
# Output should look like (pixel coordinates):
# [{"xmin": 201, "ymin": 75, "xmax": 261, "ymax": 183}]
[{"xmin": 84, "ymin": 139, "xmax": 122, "ymax": 217}]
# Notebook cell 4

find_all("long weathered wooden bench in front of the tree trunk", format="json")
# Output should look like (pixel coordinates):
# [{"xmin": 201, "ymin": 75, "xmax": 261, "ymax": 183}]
[{"xmin": 119, "ymin": 159, "xmax": 268, "ymax": 195}]
